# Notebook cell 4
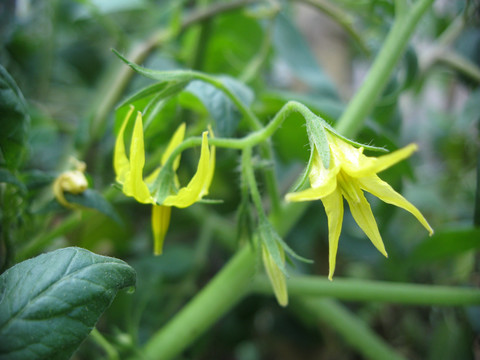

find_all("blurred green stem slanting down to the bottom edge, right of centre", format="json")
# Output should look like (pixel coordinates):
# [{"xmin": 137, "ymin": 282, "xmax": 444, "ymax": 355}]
[{"xmin": 293, "ymin": 298, "xmax": 405, "ymax": 360}]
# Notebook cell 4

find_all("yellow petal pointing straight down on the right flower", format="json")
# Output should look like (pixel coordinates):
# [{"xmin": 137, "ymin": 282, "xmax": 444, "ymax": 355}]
[{"xmin": 322, "ymin": 191, "xmax": 343, "ymax": 280}]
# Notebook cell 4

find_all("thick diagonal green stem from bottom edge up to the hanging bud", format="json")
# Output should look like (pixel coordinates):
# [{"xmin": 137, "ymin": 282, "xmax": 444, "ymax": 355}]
[{"xmin": 142, "ymin": 247, "xmax": 256, "ymax": 360}]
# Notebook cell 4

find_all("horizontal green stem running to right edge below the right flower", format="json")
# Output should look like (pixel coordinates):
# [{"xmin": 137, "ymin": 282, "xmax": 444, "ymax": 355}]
[{"xmin": 252, "ymin": 276, "xmax": 480, "ymax": 306}]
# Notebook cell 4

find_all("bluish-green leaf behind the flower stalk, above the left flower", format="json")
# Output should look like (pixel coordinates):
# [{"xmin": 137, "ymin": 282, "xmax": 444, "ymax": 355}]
[{"xmin": 181, "ymin": 76, "xmax": 253, "ymax": 137}]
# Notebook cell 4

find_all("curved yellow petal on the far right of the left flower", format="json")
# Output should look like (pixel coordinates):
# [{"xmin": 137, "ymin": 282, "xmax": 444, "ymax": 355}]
[{"xmin": 163, "ymin": 131, "xmax": 211, "ymax": 208}]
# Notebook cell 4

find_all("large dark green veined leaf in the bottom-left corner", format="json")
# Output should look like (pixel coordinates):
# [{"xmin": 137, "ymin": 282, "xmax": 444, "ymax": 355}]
[{"xmin": 0, "ymin": 248, "xmax": 136, "ymax": 360}]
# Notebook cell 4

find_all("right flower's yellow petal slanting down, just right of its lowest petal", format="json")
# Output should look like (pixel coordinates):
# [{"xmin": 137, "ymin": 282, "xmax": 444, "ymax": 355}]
[{"xmin": 343, "ymin": 183, "xmax": 388, "ymax": 257}]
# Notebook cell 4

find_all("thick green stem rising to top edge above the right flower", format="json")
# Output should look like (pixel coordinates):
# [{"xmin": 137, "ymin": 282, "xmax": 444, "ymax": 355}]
[{"xmin": 336, "ymin": 0, "xmax": 433, "ymax": 137}]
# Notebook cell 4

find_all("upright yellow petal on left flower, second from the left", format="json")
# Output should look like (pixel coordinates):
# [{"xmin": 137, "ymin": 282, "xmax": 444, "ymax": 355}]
[{"xmin": 123, "ymin": 112, "xmax": 154, "ymax": 204}]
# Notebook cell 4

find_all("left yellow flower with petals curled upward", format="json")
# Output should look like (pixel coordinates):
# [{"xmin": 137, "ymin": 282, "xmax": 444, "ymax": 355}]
[{"xmin": 113, "ymin": 107, "xmax": 215, "ymax": 255}]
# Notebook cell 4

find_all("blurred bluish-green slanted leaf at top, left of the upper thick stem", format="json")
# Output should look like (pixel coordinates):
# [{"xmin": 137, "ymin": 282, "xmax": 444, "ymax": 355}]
[{"xmin": 274, "ymin": 13, "xmax": 339, "ymax": 99}]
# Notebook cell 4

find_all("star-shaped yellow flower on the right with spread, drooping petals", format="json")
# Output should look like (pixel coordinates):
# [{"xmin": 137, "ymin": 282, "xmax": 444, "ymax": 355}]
[{"xmin": 286, "ymin": 131, "xmax": 433, "ymax": 280}]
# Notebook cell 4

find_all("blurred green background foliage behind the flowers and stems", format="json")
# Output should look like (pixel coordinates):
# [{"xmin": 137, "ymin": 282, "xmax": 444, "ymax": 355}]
[{"xmin": 0, "ymin": 0, "xmax": 480, "ymax": 360}]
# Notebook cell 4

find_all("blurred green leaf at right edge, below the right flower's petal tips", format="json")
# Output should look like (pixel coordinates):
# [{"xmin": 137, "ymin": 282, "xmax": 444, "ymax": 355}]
[{"xmin": 411, "ymin": 228, "xmax": 480, "ymax": 262}]
